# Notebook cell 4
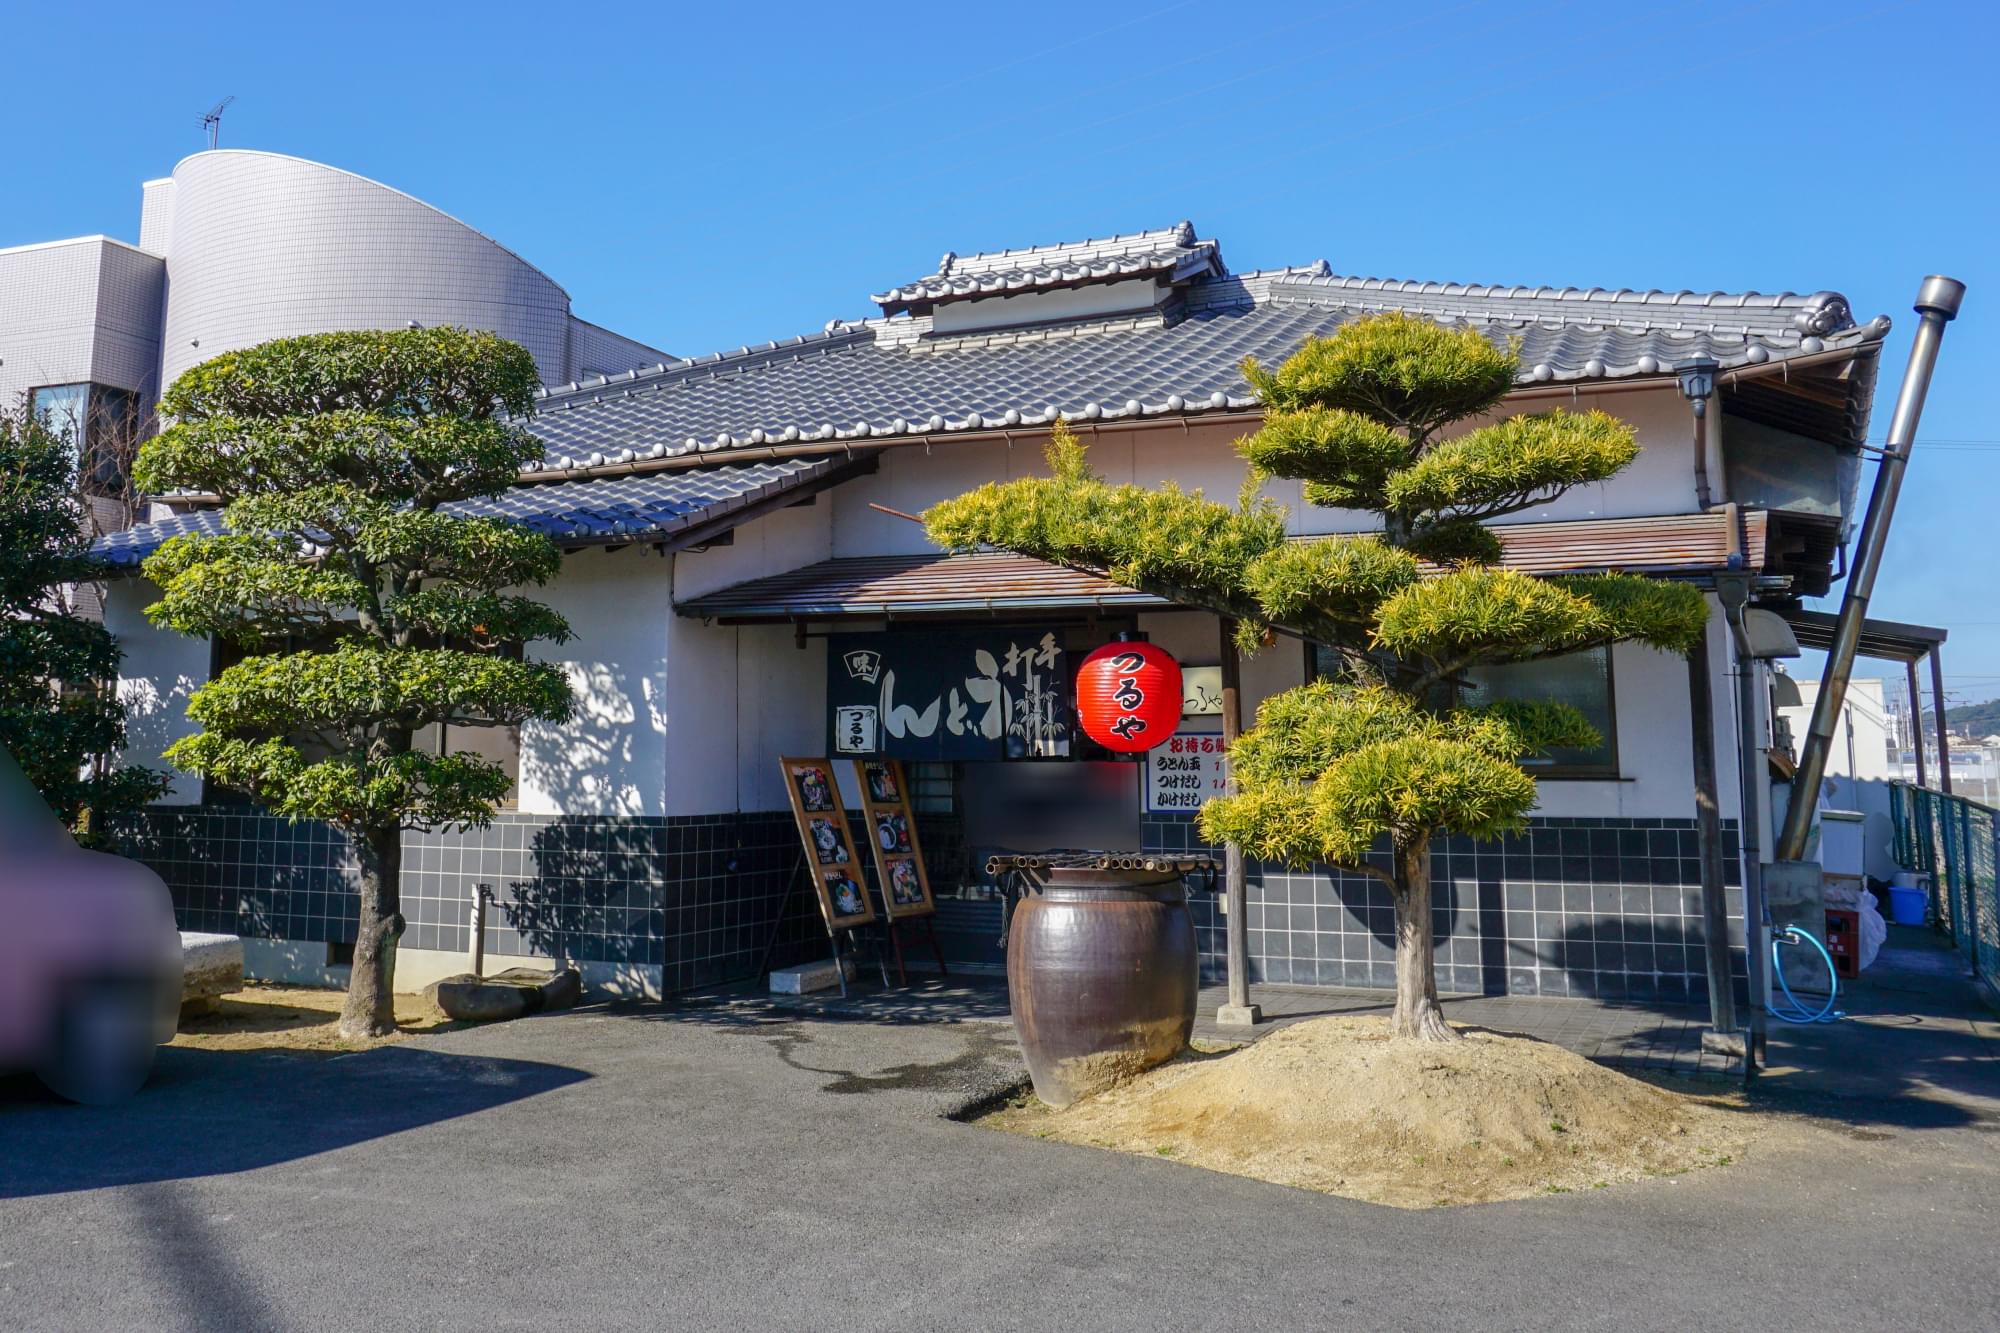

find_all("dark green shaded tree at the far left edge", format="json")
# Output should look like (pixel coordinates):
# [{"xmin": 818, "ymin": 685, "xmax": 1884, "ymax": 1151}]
[{"xmin": 0, "ymin": 404, "xmax": 166, "ymax": 845}]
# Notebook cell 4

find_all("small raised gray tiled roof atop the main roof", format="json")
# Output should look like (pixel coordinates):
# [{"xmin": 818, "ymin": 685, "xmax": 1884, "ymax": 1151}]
[{"xmin": 872, "ymin": 222, "xmax": 1222, "ymax": 314}]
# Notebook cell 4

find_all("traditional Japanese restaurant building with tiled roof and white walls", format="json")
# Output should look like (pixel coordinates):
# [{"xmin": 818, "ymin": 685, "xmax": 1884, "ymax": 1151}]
[{"xmin": 100, "ymin": 222, "xmax": 1888, "ymax": 999}]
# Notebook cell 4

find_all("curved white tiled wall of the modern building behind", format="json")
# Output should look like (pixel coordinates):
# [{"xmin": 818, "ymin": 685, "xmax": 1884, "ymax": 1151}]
[{"xmin": 156, "ymin": 148, "xmax": 576, "ymax": 384}]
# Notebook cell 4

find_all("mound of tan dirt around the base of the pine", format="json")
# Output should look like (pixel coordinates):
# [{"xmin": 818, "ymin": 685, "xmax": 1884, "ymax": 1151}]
[{"xmin": 998, "ymin": 1017, "xmax": 1748, "ymax": 1207}]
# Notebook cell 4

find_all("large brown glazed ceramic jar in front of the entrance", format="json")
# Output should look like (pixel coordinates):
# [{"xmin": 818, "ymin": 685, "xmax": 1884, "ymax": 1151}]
[{"xmin": 1006, "ymin": 867, "xmax": 1198, "ymax": 1107}]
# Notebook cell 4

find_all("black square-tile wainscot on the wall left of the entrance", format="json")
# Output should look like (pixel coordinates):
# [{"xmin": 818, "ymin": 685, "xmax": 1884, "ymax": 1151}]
[{"xmin": 122, "ymin": 807, "xmax": 826, "ymax": 991}]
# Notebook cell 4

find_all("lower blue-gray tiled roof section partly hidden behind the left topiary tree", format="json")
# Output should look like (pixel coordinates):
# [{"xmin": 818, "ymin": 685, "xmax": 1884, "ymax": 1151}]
[{"xmin": 90, "ymin": 458, "xmax": 836, "ymax": 568}]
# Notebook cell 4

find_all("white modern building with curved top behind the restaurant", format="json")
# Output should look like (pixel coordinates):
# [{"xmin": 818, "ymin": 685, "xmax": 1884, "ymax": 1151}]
[{"xmin": 0, "ymin": 148, "xmax": 672, "ymax": 440}]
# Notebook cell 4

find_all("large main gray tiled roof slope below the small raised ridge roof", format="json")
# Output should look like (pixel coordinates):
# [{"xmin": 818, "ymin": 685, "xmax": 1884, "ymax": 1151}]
[{"xmin": 530, "ymin": 266, "xmax": 1888, "ymax": 470}]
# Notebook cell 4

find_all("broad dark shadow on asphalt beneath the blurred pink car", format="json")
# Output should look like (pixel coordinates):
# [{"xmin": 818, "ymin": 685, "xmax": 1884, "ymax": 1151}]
[{"xmin": 0, "ymin": 1047, "xmax": 590, "ymax": 1199}]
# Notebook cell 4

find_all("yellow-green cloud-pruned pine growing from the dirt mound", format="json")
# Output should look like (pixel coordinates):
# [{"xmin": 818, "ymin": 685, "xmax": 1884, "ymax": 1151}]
[{"xmin": 924, "ymin": 314, "xmax": 1708, "ymax": 1041}]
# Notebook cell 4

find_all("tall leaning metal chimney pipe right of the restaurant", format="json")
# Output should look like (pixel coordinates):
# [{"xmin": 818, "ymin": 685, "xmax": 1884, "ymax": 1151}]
[{"xmin": 1776, "ymin": 274, "xmax": 1966, "ymax": 861}]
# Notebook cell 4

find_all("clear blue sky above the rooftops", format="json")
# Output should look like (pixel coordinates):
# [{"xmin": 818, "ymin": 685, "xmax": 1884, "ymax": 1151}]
[{"xmin": 0, "ymin": 0, "xmax": 2000, "ymax": 701}]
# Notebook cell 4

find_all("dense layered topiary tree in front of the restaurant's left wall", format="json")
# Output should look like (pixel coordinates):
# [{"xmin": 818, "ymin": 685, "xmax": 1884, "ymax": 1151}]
[{"xmin": 138, "ymin": 328, "xmax": 572, "ymax": 1039}]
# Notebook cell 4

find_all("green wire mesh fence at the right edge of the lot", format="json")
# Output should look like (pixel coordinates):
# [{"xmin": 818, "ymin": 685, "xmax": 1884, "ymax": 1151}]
[{"xmin": 1890, "ymin": 783, "xmax": 2000, "ymax": 985}]
